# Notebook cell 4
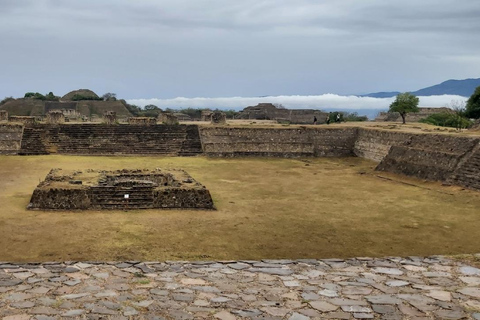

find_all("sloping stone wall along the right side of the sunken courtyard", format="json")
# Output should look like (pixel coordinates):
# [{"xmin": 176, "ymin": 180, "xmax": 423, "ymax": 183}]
[{"xmin": 354, "ymin": 129, "xmax": 480, "ymax": 187}]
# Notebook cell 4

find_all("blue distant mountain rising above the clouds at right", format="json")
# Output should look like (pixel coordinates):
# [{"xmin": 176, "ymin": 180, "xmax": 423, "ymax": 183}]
[{"xmin": 361, "ymin": 78, "xmax": 480, "ymax": 98}]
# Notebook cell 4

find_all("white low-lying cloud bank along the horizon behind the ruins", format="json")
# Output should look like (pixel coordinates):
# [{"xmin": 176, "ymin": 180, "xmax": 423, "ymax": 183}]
[{"xmin": 127, "ymin": 94, "xmax": 467, "ymax": 113}]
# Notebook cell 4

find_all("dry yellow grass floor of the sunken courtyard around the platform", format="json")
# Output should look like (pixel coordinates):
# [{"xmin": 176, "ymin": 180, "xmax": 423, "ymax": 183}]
[{"xmin": 0, "ymin": 156, "xmax": 480, "ymax": 261}]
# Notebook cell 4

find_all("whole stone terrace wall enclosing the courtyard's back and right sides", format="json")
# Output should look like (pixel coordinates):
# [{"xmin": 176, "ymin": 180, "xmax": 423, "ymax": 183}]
[{"xmin": 0, "ymin": 122, "xmax": 480, "ymax": 189}]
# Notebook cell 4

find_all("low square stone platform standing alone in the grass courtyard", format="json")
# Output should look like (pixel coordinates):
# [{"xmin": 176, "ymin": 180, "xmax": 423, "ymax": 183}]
[{"xmin": 28, "ymin": 168, "xmax": 214, "ymax": 210}]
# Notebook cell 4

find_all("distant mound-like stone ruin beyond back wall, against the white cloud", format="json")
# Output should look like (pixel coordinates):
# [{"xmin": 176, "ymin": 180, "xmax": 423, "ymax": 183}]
[{"xmin": 237, "ymin": 103, "xmax": 328, "ymax": 124}]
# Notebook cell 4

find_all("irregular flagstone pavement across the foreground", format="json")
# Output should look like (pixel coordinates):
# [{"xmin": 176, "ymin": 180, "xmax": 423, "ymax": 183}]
[{"xmin": 0, "ymin": 256, "xmax": 480, "ymax": 320}]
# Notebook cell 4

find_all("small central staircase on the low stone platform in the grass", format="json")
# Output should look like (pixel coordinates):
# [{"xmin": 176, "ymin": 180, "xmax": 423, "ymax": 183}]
[{"xmin": 89, "ymin": 186, "xmax": 153, "ymax": 210}]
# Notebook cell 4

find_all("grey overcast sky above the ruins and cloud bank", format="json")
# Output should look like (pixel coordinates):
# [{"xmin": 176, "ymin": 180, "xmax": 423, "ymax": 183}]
[{"xmin": 0, "ymin": 0, "xmax": 480, "ymax": 99}]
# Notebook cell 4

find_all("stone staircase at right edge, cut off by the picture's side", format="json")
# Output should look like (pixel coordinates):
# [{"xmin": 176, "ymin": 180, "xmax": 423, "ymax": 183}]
[{"xmin": 447, "ymin": 142, "xmax": 480, "ymax": 190}]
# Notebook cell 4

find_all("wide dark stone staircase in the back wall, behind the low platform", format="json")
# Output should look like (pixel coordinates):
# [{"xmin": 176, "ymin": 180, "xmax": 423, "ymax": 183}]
[{"xmin": 18, "ymin": 124, "xmax": 202, "ymax": 156}]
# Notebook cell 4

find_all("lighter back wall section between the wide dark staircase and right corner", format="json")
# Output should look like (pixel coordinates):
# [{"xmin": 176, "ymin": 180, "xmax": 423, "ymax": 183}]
[{"xmin": 200, "ymin": 127, "xmax": 357, "ymax": 157}]
